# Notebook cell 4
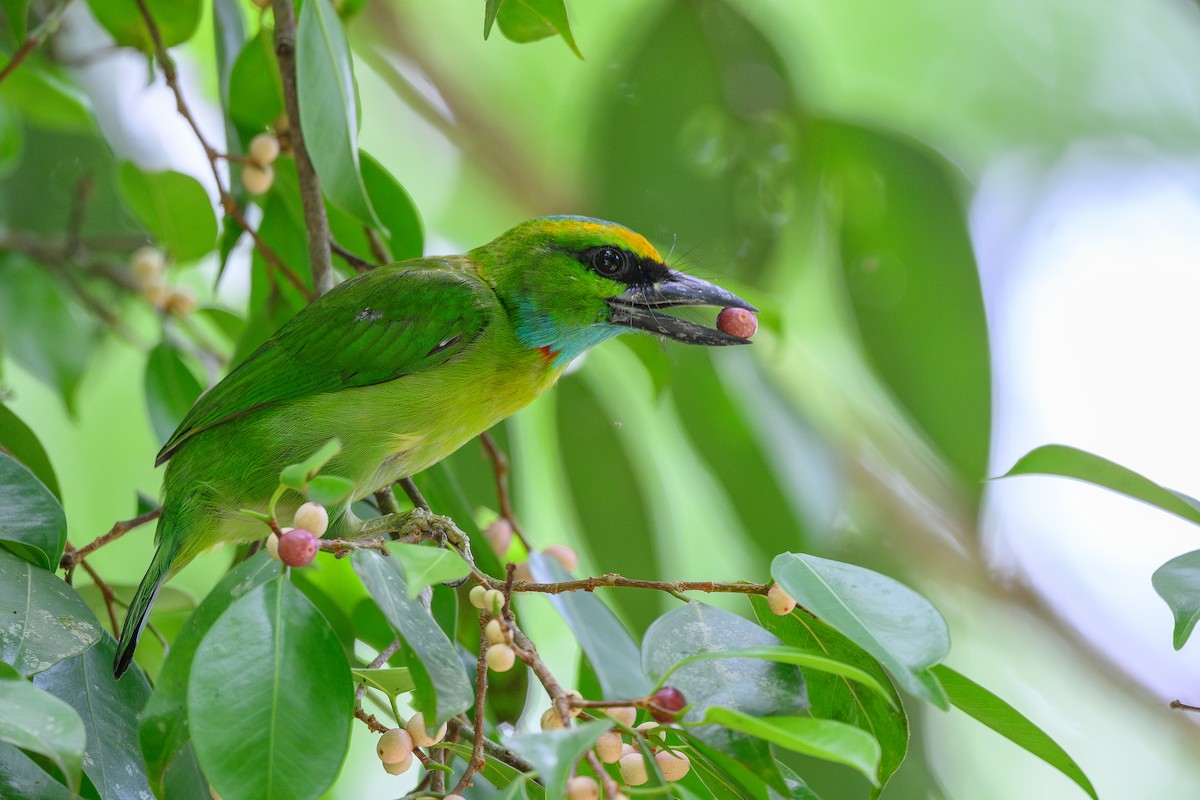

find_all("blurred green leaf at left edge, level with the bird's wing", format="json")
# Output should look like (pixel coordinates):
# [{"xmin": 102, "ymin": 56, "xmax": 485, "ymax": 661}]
[{"xmin": 0, "ymin": 255, "xmax": 96, "ymax": 410}]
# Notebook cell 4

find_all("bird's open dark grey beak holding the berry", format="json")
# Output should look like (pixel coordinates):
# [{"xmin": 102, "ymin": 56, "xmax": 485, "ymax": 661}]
[{"xmin": 607, "ymin": 272, "xmax": 758, "ymax": 345}]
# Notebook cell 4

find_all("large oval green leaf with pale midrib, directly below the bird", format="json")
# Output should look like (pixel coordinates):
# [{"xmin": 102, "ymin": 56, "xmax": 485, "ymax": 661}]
[{"xmin": 187, "ymin": 576, "xmax": 354, "ymax": 800}]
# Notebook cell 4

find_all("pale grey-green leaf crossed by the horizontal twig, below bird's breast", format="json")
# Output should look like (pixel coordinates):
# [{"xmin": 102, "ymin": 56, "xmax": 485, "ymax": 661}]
[{"xmin": 529, "ymin": 553, "xmax": 653, "ymax": 699}]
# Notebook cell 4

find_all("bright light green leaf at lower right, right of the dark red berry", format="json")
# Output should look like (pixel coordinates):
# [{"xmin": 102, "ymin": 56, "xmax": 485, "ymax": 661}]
[{"xmin": 704, "ymin": 706, "xmax": 880, "ymax": 786}]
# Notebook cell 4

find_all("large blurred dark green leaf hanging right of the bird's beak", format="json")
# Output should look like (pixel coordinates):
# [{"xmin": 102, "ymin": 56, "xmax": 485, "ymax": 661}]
[{"xmin": 804, "ymin": 121, "xmax": 991, "ymax": 495}]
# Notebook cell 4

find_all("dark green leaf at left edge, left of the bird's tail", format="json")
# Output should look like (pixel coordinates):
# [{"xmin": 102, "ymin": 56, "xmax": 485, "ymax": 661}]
[{"xmin": 0, "ymin": 452, "xmax": 67, "ymax": 572}]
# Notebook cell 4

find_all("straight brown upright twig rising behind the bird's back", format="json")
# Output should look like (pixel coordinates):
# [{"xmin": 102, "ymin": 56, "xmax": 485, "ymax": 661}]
[{"xmin": 268, "ymin": 0, "xmax": 334, "ymax": 296}]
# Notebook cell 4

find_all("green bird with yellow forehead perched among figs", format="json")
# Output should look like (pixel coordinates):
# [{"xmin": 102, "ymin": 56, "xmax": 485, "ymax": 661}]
[{"xmin": 113, "ymin": 217, "xmax": 756, "ymax": 678}]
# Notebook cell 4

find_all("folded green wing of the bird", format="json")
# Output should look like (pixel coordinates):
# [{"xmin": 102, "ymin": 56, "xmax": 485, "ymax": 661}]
[{"xmin": 155, "ymin": 266, "xmax": 497, "ymax": 465}]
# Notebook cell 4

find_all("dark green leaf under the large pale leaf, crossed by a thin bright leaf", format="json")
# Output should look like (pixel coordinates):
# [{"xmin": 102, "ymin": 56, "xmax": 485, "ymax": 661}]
[{"xmin": 749, "ymin": 596, "xmax": 908, "ymax": 786}]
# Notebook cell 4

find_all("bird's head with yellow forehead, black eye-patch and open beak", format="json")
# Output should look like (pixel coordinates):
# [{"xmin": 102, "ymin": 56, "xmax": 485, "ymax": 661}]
[{"xmin": 472, "ymin": 217, "xmax": 757, "ymax": 365}]
